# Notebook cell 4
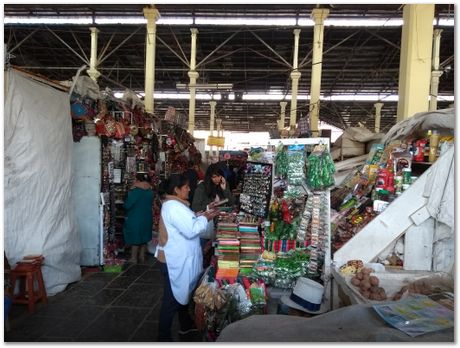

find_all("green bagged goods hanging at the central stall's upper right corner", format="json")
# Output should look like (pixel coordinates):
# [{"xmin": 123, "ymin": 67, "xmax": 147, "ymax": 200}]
[{"xmin": 307, "ymin": 144, "xmax": 335, "ymax": 190}]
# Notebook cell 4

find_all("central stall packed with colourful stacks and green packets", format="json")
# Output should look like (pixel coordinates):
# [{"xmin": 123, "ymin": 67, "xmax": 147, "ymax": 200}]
[{"xmin": 190, "ymin": 138, "xmax": 334, "ymax": 341}]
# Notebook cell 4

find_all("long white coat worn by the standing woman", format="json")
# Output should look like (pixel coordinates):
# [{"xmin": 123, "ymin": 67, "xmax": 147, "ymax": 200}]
[{"xmin": 161, "ymin": 200, "xmax": 208, "ymax": 305}]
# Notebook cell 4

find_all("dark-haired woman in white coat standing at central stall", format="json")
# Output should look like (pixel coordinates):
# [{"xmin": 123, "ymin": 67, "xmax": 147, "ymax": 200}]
[{"xmin": 156, "ymin": 174, "xmax": 219, "ymax": 341}]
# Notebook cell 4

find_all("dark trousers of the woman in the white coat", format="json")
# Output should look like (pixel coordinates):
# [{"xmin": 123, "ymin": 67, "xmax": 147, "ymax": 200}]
[{"xmin": 158, "ymin": 262, "xmax": 195, "ymax": 342}]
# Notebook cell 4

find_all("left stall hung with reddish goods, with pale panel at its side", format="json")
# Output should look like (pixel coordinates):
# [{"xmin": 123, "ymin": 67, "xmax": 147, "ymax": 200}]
[{"xmin": 70, "ymin": 77, "xmax": 201, "ymax": 269}]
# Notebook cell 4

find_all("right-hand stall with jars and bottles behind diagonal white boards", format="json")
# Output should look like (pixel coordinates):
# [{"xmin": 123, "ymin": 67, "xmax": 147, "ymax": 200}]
[{"xmin": 331, "ymin": 109, "xmax": 454, "ymax": 308}]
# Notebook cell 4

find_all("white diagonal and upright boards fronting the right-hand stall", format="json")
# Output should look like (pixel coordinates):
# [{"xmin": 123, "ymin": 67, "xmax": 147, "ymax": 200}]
[{"xmin": 331, "ymin": 147, "xmax": 454, "ymax": 308}]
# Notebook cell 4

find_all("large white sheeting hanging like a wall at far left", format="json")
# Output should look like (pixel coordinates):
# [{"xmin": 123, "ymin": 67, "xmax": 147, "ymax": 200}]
[{"xmin": 4, "ymin": 70, "xmax": 81, "ymax": 295}]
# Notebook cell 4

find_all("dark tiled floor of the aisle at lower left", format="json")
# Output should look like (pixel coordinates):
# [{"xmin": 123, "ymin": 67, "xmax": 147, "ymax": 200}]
[{"xmin": 5, "ymin": 255, "xmax": 200, "ymax": 342}]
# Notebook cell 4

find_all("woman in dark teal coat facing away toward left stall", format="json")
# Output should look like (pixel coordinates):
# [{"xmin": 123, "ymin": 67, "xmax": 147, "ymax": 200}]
[{"xmin": 123, "ymin": 173, "xmax": 153, "ymax": 263}]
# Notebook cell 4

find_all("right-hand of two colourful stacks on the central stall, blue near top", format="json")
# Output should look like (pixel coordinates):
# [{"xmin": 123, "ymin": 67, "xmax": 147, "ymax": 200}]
[{"xmin": 238, "ymin": 222, "xmax": 262, "ymax": 270}]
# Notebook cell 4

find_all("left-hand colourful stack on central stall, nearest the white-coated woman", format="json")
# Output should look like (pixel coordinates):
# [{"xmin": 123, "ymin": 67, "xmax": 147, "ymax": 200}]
[{"xmin": 216, "ymin": 222, "xmax": 240, "ymax": 279}]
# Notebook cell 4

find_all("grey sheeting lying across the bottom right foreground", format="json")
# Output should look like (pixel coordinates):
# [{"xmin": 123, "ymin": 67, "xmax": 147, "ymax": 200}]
[{"xmin": 217, "ymin": 304, "xmax": 454, "ymax": 343}]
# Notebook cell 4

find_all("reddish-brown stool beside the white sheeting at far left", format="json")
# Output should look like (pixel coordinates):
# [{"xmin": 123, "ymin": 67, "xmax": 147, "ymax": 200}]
[{"xmin": 11, "ymin": 255, "xmax": 48, "ymax": 313}]
